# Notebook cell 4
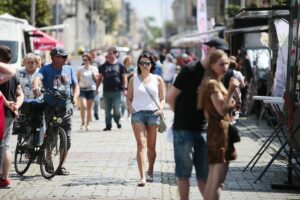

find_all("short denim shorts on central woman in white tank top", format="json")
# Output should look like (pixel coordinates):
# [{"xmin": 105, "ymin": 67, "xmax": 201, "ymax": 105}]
[{"xmin": 131, "ymin": 110, "xmax": 160, "ymax": 126}]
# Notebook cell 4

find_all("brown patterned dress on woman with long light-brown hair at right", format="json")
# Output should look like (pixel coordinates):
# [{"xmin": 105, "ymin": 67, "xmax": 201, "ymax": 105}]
[{"xmin": 201, "ymin": 81, "xmax": 237, "ymax": 164}]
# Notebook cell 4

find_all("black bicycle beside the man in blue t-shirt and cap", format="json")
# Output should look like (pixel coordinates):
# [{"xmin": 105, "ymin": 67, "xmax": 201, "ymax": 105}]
[{"xmin": 14, "ymin": 89, "xmax": 71, "ymax": 179}]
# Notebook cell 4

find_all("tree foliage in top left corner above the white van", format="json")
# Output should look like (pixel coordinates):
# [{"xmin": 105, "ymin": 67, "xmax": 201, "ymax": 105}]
[{"xmin": 0, "ymin": 0, "xmax": 51, "ymax": 27}]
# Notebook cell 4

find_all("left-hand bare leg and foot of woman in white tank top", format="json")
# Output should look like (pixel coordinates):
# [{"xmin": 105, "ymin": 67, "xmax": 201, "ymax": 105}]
[{"xmin": 132, "ymin": 123, "xmax": 147, "ymax": 183}]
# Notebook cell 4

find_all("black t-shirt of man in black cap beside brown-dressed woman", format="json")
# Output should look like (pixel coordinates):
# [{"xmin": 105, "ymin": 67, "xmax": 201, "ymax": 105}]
[{"xmin": 173, "ymin": 61, "xmax": 206, "ymax": 132}]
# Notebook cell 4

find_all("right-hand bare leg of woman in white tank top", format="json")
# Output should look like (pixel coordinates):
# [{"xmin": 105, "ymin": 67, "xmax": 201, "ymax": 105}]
[{"xmin": 146, "ymin": 125, "xmax": 158, "ymax": 176}]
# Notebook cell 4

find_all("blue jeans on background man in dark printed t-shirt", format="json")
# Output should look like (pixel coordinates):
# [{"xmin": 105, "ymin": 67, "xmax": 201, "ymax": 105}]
[{"xmin": 103, "ymin": 91, "xmax": 121, "ymax": 128}]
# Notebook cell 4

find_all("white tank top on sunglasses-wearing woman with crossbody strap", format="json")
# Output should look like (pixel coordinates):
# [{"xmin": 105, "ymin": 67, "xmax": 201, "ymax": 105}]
[{"xmin": 132, "ymin": 74, "xmax": 159, "ymax": 112}]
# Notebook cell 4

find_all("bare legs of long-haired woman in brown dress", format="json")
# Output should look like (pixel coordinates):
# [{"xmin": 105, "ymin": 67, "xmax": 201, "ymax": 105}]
[{"xmin": 204, "ymin": 163, "xmax": 229, "ymax": 200}]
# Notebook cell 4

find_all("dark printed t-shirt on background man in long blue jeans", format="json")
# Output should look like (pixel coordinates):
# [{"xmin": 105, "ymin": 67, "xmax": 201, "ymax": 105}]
[{"xmin": 99, "ymin": 62, "xmax": 127, "ymax": 91}]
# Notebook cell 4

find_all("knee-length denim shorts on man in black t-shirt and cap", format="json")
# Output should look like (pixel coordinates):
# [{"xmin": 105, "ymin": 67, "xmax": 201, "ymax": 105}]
[{"xmin": 173, "ymin": 130, "xmax": 208, "ymax": 181}]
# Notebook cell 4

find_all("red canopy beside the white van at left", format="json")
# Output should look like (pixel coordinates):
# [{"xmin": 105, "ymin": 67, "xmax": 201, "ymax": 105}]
[{"xmin": 31, "ymin": 30, "xmax": 63, "ymax": 51}]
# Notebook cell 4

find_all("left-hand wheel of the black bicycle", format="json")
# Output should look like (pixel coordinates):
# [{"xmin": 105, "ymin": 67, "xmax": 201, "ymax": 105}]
[{"xmin": 14, "ymin": 135, "xmax": 35, "ymax": 175}]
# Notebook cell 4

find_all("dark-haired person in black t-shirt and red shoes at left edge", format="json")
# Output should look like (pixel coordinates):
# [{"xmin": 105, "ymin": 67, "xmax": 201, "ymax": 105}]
[{"xmin": 0, "ymin": 45, "xmax": 24, "ymax": 188}]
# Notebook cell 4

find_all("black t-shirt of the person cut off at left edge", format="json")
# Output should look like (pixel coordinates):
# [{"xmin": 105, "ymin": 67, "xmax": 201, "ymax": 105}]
[{"xmin": 0, "ymin": 76, "xmax": 20, "ymax": 117}]
